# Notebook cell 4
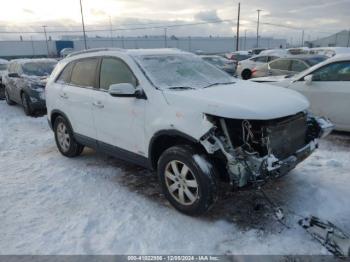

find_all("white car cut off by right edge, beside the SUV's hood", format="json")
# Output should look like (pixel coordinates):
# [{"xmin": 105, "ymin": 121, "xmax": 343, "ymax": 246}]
[{"xmin": 252, "ymin": 54, "xmax": 350, "ymax": 132}]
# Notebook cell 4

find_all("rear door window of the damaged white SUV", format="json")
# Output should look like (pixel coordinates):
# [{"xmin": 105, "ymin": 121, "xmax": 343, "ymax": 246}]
[{"xmin": 70, "ymin": 58, "xmax": 98, "ymax": 87}]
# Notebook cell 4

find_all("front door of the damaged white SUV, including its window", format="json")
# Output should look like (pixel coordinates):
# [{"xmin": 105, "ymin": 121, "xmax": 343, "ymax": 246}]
[{"xmin": 93, "ymin": 57, "xmax": 147, "ymax": 156}]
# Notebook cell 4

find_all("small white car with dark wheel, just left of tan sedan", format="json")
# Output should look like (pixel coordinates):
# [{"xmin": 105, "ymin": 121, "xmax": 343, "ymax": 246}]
[{"xmin": 236, "ymin": 55, "xmax": 280, "ymax": 80}]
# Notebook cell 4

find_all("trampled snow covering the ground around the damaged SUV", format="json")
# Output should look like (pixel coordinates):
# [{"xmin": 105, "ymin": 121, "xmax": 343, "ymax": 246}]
[{"xmin": 0, "ymin": 101, "xmax": 350, "ymax": 254}]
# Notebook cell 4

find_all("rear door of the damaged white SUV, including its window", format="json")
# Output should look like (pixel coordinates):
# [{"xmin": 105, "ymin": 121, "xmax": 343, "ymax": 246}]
[{"xmin": 59, "ymin": 57, "xmax": 99, "ymax": 139}]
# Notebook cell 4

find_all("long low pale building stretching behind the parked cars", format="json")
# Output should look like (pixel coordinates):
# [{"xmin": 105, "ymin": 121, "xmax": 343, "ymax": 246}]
[{"xmin": 0, "ymin": 35, "xmax": 287, "ymax": 59}]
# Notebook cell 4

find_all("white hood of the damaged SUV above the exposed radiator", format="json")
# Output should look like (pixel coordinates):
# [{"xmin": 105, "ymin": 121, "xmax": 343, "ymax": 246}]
[{"xmin": 163, "ymin": 80, "xmax": 309, "ymax": 120}]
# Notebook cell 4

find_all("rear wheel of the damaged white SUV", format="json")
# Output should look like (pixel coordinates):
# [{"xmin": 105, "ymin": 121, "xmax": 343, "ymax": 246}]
[{"xmin": 54, "ymin": 116, "xmax": 84, "ymax": 158}]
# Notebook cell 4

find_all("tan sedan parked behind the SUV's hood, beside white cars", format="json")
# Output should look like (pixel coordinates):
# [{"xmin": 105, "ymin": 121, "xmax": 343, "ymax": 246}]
[{"xmin": 252, "ymin": 55, "xmax": 328, "ymax": 78}]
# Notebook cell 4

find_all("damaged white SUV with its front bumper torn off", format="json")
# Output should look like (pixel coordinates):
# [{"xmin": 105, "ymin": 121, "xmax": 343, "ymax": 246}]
[{"xmin": 46, "ymin": 49, "xmax": 332, "ymax": 215}]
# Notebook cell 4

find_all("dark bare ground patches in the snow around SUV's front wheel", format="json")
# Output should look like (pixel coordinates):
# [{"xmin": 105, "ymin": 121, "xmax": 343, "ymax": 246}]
[{"xmin": 84, "ymin": 149, "xmax": 293, "ymax": 233}]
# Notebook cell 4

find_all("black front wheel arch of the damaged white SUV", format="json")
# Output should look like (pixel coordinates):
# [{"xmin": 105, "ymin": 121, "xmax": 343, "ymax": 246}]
[{"xmin": 148, "ymin": 130, "xmax": 204, "ymax": 170}]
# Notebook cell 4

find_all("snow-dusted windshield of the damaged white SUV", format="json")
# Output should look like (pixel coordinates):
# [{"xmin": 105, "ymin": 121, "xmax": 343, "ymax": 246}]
[{"xmin": 135, "ymin": 54, "xmax": 234, "ymax": 89}]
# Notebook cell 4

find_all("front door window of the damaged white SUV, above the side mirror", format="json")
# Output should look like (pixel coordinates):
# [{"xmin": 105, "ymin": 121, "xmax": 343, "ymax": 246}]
[{"xmin": 100, "ymin": 58, "xmax": 137, "ymax": 90}]
